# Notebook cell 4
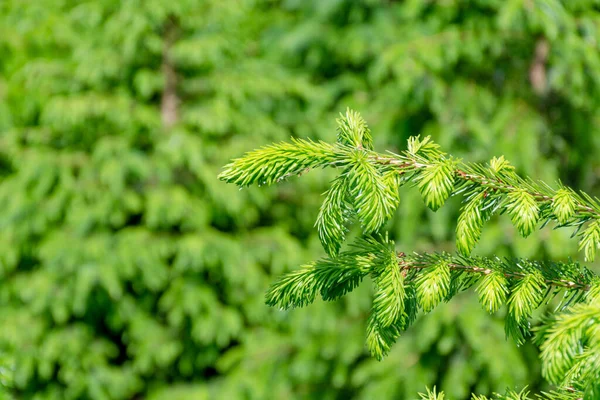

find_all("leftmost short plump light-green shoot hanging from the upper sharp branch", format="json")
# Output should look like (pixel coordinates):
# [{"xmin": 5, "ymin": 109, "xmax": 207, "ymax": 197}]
[{"xmin": 417, "ymin": 159, "xmax": 454, "ymax": 211}]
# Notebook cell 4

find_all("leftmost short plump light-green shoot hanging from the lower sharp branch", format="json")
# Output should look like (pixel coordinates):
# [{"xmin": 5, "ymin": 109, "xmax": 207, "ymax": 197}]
[{"xmin": 416, "ymin": 260, "xmax": 450, "ymax": 313}]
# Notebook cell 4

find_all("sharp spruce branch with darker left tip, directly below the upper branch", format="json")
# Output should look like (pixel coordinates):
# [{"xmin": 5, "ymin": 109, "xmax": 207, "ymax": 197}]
[{"xmin": 266, "ymin": 233, "xmax": 600, "ymax": 358}]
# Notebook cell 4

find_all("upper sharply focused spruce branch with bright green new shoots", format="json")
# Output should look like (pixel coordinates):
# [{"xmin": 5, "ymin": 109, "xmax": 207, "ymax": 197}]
[{"xmin": 219, "ymin": 110, "xmax": 600, "ymax": 261}]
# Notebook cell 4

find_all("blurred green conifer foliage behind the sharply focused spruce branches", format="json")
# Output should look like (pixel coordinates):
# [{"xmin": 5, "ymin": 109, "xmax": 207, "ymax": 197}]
[{"xmin": 0, "ymin": 0, "xmax": 600, "ymax": 400}]
